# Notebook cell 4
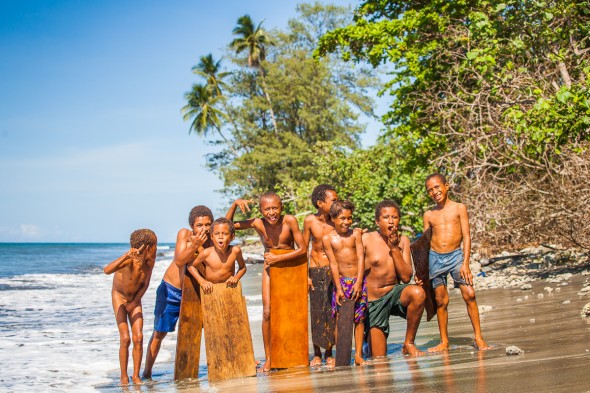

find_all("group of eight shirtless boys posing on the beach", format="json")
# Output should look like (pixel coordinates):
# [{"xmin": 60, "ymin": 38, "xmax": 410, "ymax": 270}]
[{"xmin": 104, "ymin": 174, "xmax": 488, "ymax": 384}]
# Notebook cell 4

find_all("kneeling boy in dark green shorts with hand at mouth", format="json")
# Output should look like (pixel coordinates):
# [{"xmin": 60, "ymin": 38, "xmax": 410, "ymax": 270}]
[{"xmin": 363, "ymin": 200, "xmax": 426, "ymax": 357}]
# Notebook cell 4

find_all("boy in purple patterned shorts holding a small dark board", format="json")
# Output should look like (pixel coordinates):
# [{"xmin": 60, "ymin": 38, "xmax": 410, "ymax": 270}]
[{"xmin": 322, "ymin": 200, "xmax": 367, "ymax": 365}]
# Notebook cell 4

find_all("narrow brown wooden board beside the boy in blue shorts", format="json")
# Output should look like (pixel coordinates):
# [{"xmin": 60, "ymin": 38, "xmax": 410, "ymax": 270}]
[{"xmin": 174, "ymin": 272, "xmax": 203, "ymax": 381}]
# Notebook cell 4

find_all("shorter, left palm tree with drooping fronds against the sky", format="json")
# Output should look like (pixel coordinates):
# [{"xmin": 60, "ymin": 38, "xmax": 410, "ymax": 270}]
[{"xmin": 182, "ymin": 84, "xmax": 238, "ymax": 157}]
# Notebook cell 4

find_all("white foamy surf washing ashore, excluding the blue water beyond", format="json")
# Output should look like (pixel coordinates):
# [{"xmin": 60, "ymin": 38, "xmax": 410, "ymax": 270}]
[{"xmin": 0, "ymin": 253, "xmax": 262, "ymax": 392}]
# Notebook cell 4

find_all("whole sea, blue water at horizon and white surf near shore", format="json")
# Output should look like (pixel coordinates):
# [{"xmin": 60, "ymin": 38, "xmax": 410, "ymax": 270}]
[{"xmin": 0, "ymin": 243, "xmax": 262, "ymax": 392}]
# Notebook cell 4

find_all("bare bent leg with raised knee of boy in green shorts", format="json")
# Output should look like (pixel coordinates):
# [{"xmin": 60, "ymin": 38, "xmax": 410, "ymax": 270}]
[{"xmin": 400, "ymin": 285, "xmax": 426, "ymax": 356}]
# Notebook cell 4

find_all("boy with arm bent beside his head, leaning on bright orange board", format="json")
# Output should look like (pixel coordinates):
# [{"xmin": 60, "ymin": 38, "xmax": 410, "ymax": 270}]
[{"xmin": 225, "ymin": 192, "xmax": 307, "ymax": 371}]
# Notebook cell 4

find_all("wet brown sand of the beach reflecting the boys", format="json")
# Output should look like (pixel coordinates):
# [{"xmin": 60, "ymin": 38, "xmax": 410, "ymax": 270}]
[{"xmin": 97, "ymin": 273, "xmax": 590, "ymax": 393}]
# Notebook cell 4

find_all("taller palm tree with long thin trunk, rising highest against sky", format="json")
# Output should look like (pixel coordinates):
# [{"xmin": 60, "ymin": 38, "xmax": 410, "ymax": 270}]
[{"xmin": 230, "ymin": 15, "xmax": 278, "ymax": 136}]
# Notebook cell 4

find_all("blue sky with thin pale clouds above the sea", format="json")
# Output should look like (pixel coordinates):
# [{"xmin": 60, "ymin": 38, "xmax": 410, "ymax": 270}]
[{"xmin": 0, "ymin": 0, "xmax": 379, "ymax": 243}]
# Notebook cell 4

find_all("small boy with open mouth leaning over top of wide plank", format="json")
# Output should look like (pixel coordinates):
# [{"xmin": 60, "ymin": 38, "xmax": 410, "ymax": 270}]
[{"xmin": 188, "ymin": 217, "xmax": 247, "ymax": 290}]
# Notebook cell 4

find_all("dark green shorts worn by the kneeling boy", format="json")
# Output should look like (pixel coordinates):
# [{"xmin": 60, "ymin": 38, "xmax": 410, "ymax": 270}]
[{"xmin": 365, "ymin": 284, "xmax": 411, "ymax": 337}]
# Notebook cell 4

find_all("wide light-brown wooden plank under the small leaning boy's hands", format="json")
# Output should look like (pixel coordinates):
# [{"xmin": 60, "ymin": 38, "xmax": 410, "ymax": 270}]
[{"xmin": 201, "ymin": 281, "xmax": 256, "ymax": 381}]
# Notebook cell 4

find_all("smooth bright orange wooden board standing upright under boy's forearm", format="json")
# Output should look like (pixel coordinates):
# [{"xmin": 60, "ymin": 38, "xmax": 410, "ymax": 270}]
[{"xmin": 269, "ymin": 250, "xmax": 309, "ymax": 368}]
